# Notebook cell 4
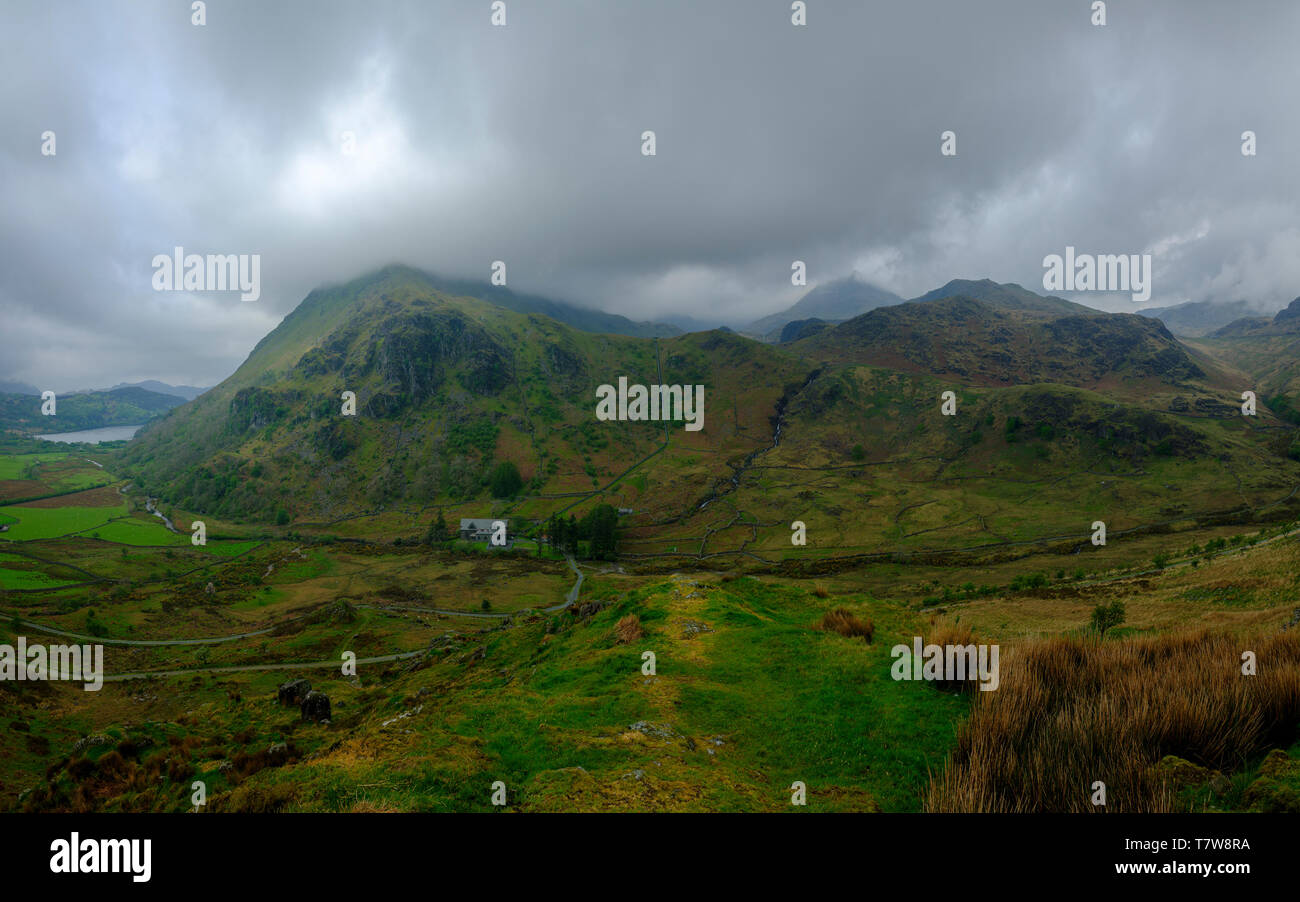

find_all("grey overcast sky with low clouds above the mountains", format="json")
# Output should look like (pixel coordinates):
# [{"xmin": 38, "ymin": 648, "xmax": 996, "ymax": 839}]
[{"xmin": 0, "ymin": 0, "xmax": 1300, "ymax": 391}]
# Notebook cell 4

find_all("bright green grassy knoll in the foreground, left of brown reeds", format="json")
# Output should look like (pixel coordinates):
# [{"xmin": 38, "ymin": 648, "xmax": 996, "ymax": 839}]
[{"xmin": 7, "ymin": 580, "xmax": 965, "ymax": 811}]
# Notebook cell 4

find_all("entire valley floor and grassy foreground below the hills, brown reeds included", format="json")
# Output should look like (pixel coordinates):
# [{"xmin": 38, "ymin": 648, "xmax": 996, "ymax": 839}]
[{"xmin": 0, "ymin": 455, "xmax": 1300, "ymax": 811}]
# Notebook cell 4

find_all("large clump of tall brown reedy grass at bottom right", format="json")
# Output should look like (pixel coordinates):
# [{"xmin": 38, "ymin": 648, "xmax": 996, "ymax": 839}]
[{"xmin": 926, "ymin": 632, "xmax": 1300, "ymax": 812}]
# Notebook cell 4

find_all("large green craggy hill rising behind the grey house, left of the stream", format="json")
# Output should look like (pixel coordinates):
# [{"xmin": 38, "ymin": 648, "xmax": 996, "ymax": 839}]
[{"xmin": 124, "ymin": 269, "xmax": 805, "ymax": 520}]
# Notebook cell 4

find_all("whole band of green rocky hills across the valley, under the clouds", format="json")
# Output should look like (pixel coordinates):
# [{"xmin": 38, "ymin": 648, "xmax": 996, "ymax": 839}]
[{"xmin": 109, "ymin": 269, "xmax": 1300, "ymax": 567}]
